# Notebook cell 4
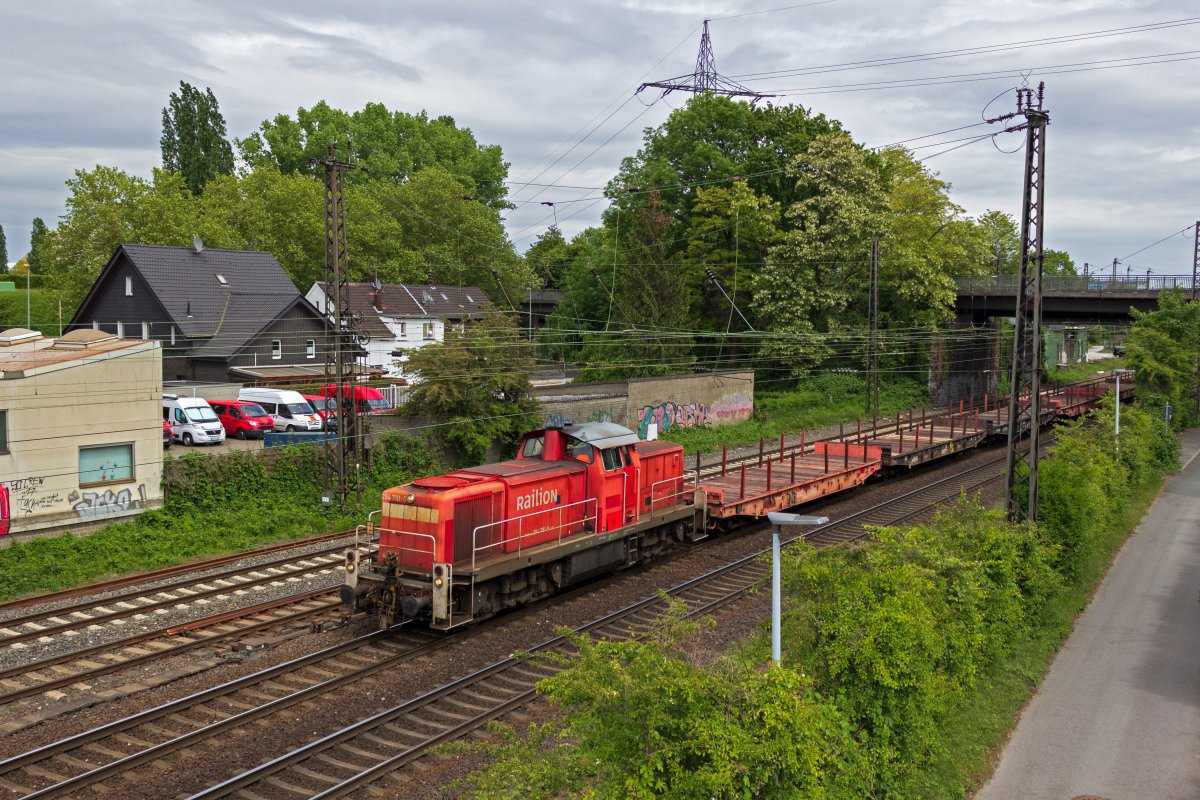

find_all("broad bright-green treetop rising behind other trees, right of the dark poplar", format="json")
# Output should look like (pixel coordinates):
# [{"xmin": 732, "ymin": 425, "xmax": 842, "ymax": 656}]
[{"xmin": 238, "ymin": 101, "xmax": 509, "ymax": 211}]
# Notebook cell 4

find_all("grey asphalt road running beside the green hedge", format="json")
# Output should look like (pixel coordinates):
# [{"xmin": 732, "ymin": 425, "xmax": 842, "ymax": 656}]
[{"xmin": 976, "ymin": 431, "xmax": 1200, "ymax": 800}]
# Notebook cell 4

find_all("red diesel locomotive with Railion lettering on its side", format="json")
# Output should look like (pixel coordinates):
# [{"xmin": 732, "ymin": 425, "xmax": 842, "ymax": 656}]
[{"xmin": 342, "ymin": 422, "xmax": 704, "ymax": 630}]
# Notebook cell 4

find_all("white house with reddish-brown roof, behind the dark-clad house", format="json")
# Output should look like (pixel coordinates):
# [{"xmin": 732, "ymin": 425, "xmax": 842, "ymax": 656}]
[{"xmin": 305, "ymin": 281, "xmax": 492, "ymax": 378}]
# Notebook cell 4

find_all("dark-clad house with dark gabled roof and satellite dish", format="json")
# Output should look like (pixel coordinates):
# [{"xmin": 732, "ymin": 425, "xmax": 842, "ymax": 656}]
[{"xmin": 70, "ymin": 240, "xmax": 350, "ymax": 384}]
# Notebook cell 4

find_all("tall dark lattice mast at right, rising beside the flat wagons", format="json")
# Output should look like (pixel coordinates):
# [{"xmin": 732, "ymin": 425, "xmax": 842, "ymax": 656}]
[{"xmin": 1004, "ymin": 84, "xmax": 1050, "ymax": 522}]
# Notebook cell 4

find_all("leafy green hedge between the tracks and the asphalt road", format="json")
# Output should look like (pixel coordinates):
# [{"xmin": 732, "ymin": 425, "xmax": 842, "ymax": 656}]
[{"xmin": 466, "ymin": 403, "xmax": 1178, "ymax": 800}]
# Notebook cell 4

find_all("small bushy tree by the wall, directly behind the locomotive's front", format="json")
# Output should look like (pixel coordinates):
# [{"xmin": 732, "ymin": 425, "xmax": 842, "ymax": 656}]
[{"xmin": 404, "ymin": 311, "xmax": 541, "ymax": 464}]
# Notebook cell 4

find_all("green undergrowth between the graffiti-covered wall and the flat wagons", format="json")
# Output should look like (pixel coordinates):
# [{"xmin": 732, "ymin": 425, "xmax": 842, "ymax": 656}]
[{"xmin": 661, "ymin": 373, "xmax": 929, "ymax": 453}]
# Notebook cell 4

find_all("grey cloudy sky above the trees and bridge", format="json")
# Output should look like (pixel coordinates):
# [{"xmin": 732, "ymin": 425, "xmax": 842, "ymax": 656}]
[{"xmin": 0, "ymin": 0, "xmax": 1200, "ymax": 275}]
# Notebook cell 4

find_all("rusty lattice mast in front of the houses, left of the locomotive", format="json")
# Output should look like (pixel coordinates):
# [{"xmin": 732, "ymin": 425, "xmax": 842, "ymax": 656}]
[{"xmin": 312, "ymin": 139, "xmax": 366, "ymax": 513}]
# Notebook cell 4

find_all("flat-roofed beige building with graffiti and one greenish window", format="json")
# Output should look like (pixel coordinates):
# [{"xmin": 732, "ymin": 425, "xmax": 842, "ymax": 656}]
[{"xmin": 0, "ymin": 327, "xmax": 162, "ymax": 534}]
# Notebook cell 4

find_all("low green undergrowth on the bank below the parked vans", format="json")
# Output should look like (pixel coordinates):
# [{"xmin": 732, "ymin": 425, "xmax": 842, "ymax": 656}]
[{"xmin": 0, "ymin": 434, "xmax": 442, "ymax": 600}]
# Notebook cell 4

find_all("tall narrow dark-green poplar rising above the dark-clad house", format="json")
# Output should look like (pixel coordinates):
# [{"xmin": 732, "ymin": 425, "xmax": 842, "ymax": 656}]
[{"xmin": 160, "ymin": 80, "xmax": 233, "ymax": 194}]
